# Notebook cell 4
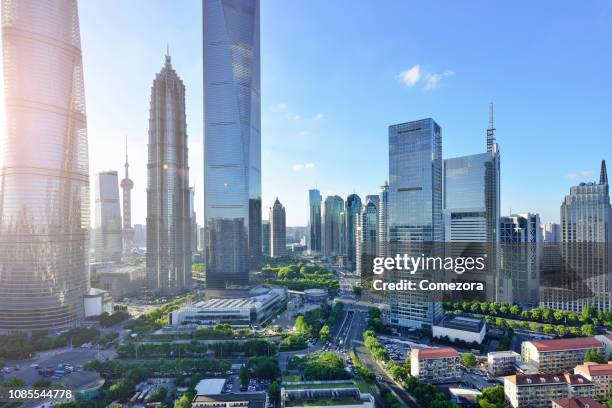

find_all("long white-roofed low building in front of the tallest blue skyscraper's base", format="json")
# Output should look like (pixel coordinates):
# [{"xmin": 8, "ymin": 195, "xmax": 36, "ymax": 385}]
[{"xmin": 168, "ymin": 286, "xmax": 287, "ymax": 326}]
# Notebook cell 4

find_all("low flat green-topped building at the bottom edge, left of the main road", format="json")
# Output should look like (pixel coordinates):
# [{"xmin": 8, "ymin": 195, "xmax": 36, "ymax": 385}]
[{"xmin": 281, "ymin": 380, "xmax": 375, "ymax": 408}]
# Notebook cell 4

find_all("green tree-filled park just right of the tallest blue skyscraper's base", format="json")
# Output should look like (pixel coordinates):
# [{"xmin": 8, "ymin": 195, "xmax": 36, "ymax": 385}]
[{"xmin": 261, "ymin": 262, "xmax": 340, "ymax": 296}]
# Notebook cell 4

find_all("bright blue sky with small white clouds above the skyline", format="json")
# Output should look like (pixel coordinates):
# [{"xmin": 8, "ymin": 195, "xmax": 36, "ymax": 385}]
[{"xmin": 79, "ymin": 0, "xmax": 612, "ymax": 225}]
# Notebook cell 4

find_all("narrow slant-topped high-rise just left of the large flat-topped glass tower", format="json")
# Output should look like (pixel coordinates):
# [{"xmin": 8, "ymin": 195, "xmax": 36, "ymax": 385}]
[{"xmin": 355, "ymin": 195, "xmax": 379, "ymax": 277}]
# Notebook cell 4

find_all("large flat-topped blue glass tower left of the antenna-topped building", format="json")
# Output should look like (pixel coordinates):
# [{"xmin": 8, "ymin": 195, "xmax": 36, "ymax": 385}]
[{"xmin": 387, "ymin": 119, "xmax": 444, "ymax": 328}]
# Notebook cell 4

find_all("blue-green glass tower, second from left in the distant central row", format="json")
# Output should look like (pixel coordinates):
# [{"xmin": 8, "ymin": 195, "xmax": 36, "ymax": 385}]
[{"xmin": 321, "ymin": 196, "xmax": 344, "ymax": 258}]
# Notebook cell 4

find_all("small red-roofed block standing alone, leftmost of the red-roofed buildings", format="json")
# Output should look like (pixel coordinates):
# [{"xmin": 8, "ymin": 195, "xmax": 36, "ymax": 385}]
[{"xmin": 410, "ymin": 347, "xmax": 460, "ymax": 383}]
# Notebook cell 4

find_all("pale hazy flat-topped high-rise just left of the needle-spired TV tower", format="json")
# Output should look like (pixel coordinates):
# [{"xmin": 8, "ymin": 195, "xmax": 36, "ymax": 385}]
[{"xmin": 94, "ymin": 170, "xmax": 123, "ymax": 262}]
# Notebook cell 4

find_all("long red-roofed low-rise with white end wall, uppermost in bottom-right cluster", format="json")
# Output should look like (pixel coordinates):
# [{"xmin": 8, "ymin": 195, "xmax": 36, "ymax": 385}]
[{"xmin": 521, "ymin": 337, "xmax": 604, "ymax": 373}]
